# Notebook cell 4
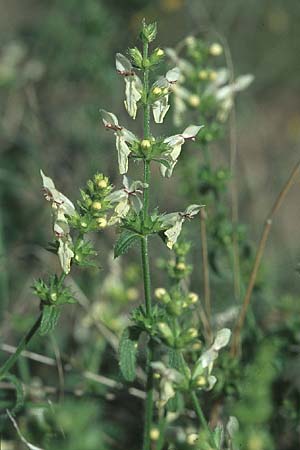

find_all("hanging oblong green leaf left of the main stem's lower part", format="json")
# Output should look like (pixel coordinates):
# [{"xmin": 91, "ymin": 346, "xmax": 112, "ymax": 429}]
[{"xmin": 119, "ymin": 326, "xmax": 141, "ymax": 381}]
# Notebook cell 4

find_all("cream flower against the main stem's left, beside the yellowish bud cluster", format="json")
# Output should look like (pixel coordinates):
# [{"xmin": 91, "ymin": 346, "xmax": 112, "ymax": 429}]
[{"xmin": 107, "ymin": 175, "xmax": 148, "ymax": 225}]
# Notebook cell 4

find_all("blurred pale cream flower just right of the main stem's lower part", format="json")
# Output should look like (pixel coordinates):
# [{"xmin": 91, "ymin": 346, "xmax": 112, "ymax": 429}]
[{"xmin": 151, "ymin": 361, "xmax": 184, "ymax": 408}]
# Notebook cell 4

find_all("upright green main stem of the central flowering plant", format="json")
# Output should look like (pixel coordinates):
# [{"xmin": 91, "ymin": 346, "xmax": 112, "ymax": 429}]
[{"xmin": 141, "ymin": 37, "xmax": 153, "ymax": 450}]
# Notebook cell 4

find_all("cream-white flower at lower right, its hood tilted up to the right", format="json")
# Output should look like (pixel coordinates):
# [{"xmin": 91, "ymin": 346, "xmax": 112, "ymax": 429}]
[{"xmin": 192, "ymin": 328, "xmax": 231, "ymax": 390}]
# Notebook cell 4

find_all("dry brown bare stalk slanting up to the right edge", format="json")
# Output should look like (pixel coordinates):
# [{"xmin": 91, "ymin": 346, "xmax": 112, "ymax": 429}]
[{"xmin": 231, "ymin": 161, "xmax": 300, "ymax": 356}]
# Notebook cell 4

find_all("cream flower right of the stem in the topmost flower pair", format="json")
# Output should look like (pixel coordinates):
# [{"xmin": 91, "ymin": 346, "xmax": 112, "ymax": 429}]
[{"xmin": 151, "ymin": 67, "xmax": 180, "ymax": 123}]
